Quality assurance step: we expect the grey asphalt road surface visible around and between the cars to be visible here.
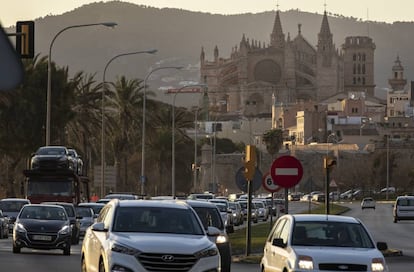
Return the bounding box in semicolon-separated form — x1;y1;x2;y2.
0;202;414;272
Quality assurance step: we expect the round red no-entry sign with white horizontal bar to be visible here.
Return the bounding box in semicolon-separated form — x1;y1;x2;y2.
270;156;303;188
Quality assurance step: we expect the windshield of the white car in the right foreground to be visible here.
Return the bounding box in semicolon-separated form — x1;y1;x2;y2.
291;221;374;248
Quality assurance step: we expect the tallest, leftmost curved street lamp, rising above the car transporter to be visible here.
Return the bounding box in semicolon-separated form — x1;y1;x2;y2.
46;22;117;145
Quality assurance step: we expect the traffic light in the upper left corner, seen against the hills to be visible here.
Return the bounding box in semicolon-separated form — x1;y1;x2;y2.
16;21;34;59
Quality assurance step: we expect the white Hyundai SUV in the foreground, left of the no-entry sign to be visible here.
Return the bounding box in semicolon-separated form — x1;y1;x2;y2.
82;199;221;272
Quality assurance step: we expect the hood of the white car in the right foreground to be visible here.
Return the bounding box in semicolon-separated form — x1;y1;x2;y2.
294;246;383;265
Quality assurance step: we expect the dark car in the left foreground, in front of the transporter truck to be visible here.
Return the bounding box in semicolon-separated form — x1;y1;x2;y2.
13;204;72;255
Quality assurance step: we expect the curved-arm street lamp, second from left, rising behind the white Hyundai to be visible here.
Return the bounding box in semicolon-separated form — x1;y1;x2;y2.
101;49;157;197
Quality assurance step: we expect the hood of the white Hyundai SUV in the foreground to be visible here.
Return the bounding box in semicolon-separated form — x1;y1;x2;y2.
113;232;213;254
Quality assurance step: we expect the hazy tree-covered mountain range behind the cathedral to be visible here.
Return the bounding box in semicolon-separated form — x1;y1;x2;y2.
5;1;414;106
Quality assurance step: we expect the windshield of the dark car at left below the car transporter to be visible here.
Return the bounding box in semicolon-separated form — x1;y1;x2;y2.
19;206;67;221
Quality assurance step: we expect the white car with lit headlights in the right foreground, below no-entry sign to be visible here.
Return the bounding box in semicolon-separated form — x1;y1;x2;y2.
260;214;388;272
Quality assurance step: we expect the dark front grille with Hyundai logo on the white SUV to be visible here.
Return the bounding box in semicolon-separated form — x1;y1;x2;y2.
137;253;197;272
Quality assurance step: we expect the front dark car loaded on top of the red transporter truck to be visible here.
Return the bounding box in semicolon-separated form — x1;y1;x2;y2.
30;146;75;171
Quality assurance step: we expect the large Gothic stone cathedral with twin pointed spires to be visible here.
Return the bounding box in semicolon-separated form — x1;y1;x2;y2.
200;10;375;117
